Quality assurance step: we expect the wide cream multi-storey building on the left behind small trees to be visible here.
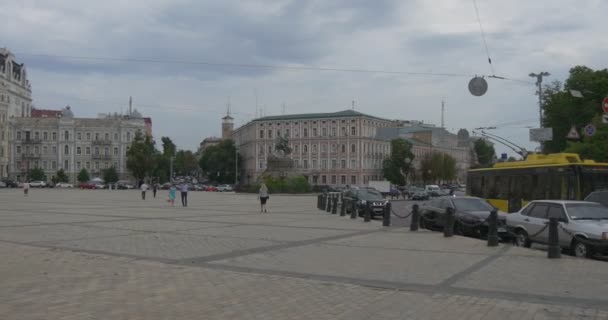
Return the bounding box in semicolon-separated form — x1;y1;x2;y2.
8;106;151;183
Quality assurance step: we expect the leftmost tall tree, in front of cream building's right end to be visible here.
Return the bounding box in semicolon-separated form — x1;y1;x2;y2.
127;131;157;180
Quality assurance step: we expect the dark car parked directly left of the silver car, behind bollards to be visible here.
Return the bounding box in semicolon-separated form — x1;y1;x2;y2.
420;197;510;240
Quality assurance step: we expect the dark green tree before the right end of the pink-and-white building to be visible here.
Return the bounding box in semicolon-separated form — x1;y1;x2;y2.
382;139;414;186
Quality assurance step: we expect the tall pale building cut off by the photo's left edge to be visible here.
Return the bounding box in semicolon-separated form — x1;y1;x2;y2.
0;48;32;178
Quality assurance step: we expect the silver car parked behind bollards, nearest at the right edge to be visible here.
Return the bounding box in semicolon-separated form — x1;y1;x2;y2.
507;200;608;257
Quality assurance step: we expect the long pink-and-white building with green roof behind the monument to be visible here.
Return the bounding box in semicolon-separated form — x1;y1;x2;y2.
232;110;392;186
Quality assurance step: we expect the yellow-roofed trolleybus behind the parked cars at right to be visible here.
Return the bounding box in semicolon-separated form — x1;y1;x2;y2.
467;153;608;212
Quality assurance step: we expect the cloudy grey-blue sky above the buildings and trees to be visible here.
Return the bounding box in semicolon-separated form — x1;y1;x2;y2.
0;0;608;155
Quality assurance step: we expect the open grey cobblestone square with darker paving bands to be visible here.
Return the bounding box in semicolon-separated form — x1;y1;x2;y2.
0;189;608;320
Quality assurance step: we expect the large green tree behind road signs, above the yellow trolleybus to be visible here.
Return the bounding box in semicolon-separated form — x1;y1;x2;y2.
543;66;608;156
